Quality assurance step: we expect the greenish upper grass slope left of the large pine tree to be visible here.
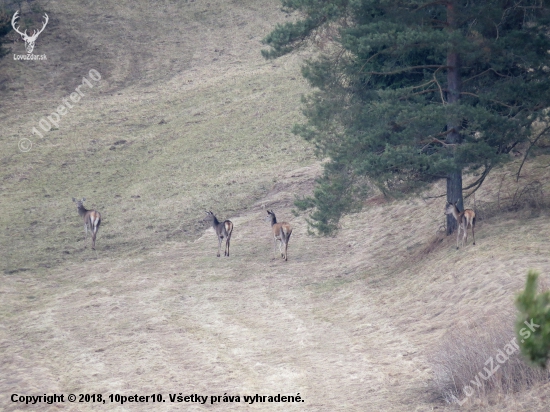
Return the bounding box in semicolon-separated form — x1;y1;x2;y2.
0;1;312;273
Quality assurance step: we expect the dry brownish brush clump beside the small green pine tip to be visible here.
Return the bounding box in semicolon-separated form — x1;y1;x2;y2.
431;308;550;406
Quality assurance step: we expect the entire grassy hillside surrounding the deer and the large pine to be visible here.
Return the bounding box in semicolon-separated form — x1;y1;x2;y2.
0;0;550;411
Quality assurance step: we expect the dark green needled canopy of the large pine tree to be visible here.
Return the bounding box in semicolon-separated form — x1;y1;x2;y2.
262;0;550;234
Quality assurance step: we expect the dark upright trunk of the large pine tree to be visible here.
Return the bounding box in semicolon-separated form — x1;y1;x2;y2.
446;1;464;235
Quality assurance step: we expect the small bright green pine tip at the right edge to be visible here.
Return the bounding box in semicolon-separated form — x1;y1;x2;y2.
516;271;550;368
